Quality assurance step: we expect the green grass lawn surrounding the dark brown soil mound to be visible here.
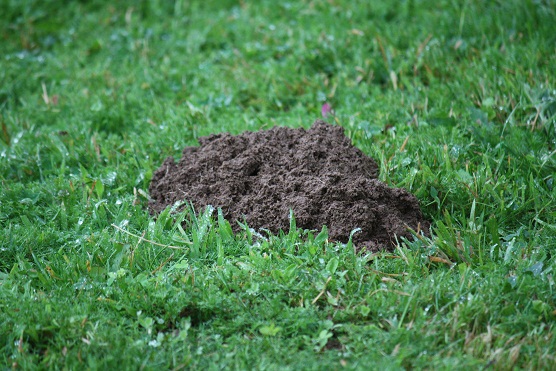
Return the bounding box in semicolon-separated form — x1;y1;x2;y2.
0;0;556;369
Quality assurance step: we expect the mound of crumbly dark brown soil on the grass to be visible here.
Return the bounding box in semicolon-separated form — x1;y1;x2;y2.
149;121;429;250
